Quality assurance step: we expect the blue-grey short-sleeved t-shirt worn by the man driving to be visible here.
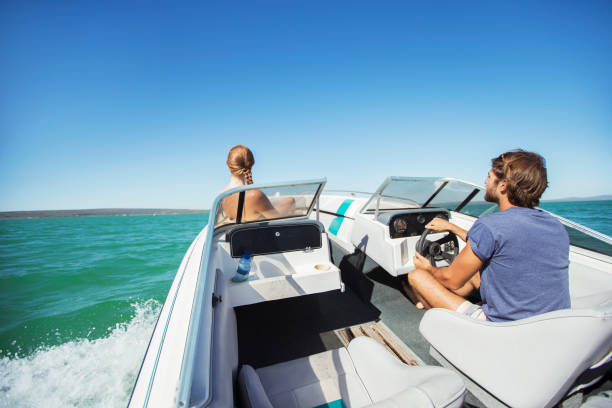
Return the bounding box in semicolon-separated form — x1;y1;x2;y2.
467;207;570;322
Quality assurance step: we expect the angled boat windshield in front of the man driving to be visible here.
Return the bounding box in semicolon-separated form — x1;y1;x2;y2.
362;177;497;217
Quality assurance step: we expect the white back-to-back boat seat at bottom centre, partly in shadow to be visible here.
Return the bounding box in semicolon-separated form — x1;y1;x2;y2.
238;337;465;408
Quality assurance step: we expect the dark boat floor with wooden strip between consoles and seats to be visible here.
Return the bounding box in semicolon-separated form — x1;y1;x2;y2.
235;243;483;407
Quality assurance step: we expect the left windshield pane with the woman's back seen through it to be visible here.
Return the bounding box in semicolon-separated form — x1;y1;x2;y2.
215;179;325;229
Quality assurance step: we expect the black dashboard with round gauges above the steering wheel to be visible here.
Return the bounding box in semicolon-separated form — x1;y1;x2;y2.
378;208;450;238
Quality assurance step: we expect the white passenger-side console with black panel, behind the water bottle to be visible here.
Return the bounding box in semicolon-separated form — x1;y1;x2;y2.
212;220;343;306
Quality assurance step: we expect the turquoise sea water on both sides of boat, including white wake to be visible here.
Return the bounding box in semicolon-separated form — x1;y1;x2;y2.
0;201;612;408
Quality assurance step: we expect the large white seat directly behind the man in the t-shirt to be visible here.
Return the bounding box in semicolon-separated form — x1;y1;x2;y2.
419;304;612;407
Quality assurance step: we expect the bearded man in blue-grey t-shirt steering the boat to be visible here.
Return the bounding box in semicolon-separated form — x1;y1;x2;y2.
408;150;570;322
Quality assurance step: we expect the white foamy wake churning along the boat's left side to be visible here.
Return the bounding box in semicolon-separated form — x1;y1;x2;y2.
0;300;161;408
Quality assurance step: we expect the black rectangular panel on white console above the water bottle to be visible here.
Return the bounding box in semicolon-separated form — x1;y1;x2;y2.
228;223;322;258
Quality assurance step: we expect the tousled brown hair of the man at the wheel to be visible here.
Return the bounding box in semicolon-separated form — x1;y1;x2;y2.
491;149;548;208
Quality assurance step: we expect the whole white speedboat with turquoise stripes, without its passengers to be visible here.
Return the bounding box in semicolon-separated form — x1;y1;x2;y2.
129;177;612;408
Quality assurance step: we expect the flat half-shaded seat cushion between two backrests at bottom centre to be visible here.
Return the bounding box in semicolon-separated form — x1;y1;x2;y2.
257;348;372;408
